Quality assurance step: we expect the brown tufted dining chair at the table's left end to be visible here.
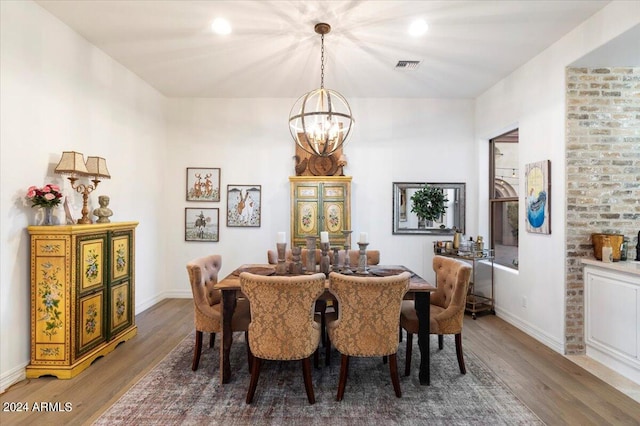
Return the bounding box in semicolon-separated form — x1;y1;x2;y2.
187;254;251;371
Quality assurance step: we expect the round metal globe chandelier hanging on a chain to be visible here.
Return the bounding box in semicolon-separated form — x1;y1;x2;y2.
289;23;355;157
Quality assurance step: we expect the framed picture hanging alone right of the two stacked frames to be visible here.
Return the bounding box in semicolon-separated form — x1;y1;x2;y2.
227;185;262;227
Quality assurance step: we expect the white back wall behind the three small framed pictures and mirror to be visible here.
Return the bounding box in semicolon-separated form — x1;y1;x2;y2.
166;99;477;297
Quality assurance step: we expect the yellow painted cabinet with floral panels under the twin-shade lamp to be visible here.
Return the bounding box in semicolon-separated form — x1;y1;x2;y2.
27;222;137;379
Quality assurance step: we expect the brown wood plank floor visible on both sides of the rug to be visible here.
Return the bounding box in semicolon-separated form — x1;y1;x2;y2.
0;299;640;426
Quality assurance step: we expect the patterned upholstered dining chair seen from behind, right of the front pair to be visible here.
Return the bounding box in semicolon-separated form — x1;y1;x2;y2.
327;272;411;401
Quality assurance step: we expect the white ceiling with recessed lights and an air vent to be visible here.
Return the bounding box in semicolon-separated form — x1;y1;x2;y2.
32;0;609;98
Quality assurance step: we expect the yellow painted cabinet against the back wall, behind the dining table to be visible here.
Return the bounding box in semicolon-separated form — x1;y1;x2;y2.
289;176;351;246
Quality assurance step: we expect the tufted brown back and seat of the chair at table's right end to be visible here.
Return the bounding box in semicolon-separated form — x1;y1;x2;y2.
431;256;471;334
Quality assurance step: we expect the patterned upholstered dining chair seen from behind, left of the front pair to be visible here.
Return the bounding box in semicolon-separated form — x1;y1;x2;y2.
240;272;326;404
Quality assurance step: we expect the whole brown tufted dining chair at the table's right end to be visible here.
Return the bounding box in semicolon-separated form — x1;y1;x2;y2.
400;256;471;376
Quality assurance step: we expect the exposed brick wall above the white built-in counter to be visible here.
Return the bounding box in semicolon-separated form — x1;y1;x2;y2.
565;67;640;354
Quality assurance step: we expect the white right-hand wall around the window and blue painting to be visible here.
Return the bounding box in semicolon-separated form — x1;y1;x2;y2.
475;2;640;352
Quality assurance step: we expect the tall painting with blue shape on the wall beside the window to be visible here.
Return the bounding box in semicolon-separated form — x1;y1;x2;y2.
525;160;551;234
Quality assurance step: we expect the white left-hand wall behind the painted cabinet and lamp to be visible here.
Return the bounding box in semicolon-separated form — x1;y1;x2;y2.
0;1;168;390
